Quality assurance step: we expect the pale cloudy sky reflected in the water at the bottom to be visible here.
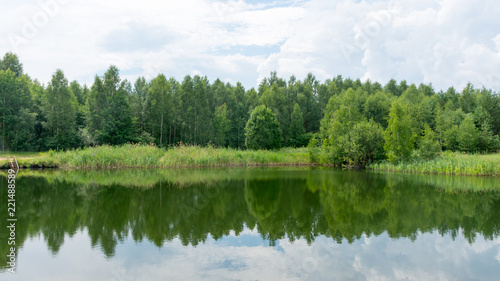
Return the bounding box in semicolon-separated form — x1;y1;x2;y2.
8;229;500;281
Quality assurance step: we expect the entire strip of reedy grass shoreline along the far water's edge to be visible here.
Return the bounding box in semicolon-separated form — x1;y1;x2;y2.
0;144;500;177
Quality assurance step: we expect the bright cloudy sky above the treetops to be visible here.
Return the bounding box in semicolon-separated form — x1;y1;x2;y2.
0;0;500;92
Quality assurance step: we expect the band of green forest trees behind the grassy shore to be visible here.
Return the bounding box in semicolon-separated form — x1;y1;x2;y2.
0;53;500;165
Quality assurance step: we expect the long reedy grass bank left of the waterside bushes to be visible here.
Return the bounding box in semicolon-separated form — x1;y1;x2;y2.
1;144;310;168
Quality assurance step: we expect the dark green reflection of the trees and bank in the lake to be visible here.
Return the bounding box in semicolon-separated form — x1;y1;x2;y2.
0;168;500;266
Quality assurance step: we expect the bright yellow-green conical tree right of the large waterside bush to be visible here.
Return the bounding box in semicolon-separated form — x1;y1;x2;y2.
384;100;417;162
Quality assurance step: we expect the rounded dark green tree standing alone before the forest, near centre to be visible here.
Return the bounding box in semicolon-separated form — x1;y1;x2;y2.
245;105;281;149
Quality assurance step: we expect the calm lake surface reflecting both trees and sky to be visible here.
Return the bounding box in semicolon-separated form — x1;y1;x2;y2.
0;168;500;281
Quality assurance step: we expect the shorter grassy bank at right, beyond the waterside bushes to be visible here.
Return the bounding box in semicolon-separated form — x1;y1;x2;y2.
369;152;500;176
